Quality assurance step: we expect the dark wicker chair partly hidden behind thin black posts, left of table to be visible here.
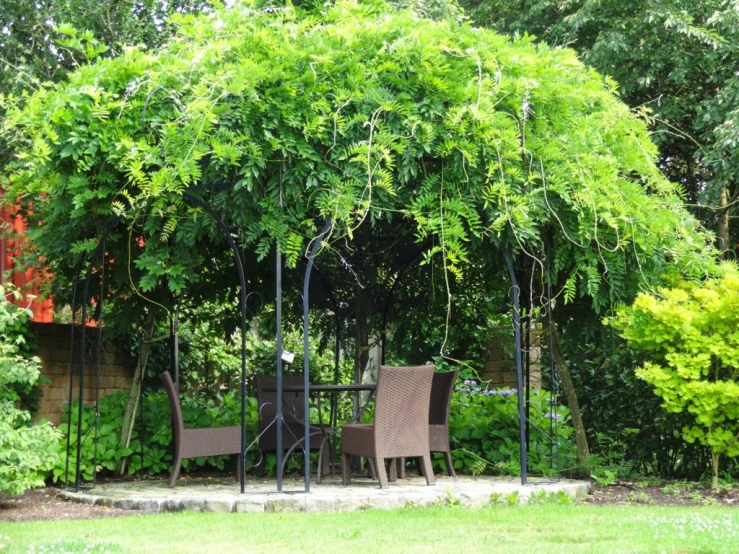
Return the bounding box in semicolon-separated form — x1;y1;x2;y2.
255;375;328;483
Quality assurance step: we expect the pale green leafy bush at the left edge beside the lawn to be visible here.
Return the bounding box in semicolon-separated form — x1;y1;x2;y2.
0;286;58;494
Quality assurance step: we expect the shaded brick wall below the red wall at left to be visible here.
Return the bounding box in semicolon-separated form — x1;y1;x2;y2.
31;323;134;424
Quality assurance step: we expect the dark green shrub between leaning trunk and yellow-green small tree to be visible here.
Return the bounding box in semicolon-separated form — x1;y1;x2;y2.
563;332;710;480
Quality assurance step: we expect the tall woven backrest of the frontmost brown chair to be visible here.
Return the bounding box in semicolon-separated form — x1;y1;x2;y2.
374;365;434;458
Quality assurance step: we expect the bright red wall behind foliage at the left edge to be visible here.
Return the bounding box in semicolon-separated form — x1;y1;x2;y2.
0;199;54;323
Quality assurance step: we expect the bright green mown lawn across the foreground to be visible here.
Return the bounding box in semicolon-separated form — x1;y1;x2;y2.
0;504;739;554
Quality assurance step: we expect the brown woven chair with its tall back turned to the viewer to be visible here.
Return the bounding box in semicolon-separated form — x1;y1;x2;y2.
341;365;435;489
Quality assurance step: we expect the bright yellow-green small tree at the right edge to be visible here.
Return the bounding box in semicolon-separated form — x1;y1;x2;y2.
611;264;739;488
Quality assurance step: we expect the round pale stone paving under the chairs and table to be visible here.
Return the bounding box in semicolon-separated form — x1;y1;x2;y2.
61;470;590;512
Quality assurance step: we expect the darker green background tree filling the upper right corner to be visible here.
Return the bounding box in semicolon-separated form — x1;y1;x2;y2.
460;0;739;254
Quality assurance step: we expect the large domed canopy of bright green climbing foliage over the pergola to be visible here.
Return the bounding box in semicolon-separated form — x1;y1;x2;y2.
4;0;711;308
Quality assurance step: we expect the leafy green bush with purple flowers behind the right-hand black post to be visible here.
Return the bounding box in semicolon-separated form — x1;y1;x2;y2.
448;380;575;475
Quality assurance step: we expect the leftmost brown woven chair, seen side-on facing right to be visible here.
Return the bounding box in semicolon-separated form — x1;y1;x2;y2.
159;371;241;488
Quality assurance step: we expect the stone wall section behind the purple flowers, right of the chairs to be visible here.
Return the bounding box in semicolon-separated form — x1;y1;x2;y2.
481;331;541;389
